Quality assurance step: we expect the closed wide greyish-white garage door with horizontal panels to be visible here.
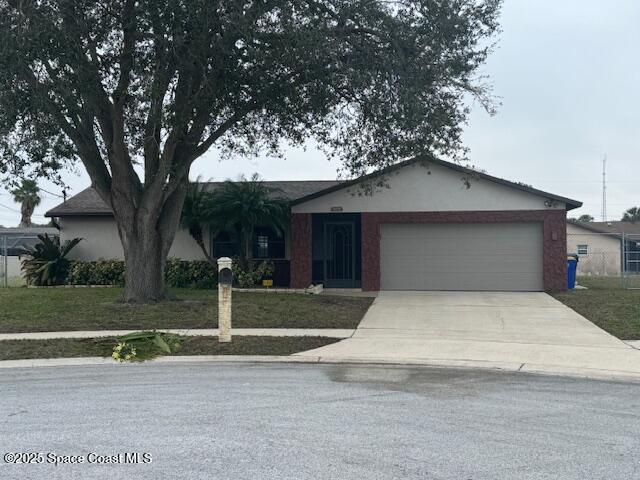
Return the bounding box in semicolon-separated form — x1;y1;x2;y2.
380;223;543;291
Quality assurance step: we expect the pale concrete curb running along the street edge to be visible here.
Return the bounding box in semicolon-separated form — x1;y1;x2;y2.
0;354;640;383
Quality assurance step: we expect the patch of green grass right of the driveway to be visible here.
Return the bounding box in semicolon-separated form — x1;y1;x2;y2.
554;277;640;340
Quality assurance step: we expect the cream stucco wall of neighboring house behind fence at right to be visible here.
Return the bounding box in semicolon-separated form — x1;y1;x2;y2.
567;223;622;276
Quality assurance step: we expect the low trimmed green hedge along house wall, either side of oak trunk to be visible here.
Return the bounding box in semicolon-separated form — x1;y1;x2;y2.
67;258;218;288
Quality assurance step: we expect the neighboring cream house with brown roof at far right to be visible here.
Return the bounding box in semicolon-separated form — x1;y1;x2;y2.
567;221;640;276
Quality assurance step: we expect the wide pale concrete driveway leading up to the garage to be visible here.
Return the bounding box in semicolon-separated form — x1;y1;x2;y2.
298;292;640;379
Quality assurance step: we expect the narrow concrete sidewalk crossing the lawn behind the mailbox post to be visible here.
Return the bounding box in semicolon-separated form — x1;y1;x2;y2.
0;328;354;341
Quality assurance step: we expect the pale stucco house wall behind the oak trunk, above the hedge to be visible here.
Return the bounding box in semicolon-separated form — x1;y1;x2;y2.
58;217;210;260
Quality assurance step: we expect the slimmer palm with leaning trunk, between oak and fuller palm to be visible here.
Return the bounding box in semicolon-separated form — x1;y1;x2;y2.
180;177;216;266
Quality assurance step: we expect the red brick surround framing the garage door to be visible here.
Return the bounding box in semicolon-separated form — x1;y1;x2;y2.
362;210;567;292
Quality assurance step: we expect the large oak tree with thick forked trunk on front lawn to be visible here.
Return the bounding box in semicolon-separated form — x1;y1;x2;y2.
0;0;500;302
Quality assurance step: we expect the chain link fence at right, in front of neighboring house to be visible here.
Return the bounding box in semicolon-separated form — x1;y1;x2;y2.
567;232;640;289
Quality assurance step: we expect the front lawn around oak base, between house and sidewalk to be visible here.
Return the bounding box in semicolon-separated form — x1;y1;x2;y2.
0;288;373;333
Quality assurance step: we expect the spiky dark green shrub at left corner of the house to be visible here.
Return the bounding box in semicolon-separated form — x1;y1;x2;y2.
22;233;82;286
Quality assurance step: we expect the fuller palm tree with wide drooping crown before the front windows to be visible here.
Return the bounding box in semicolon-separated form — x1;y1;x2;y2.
209;173;290;270
